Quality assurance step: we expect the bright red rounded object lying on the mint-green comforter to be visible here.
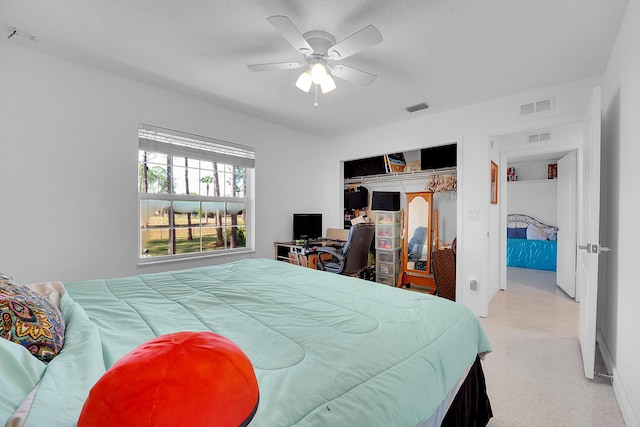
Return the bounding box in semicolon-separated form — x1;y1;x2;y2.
78;332;259;427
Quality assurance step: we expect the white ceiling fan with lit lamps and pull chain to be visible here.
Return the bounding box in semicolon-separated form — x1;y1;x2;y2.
247;15;382;107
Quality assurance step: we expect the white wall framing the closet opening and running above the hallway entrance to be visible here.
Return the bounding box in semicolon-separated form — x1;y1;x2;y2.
327;78;600;316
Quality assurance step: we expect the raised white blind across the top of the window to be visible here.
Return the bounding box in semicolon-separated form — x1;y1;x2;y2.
138;124;255;168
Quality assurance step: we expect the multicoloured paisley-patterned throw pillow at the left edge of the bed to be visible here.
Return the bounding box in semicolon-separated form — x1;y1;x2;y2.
0;273;65;362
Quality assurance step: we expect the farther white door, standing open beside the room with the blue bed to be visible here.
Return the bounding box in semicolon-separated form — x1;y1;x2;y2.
556;151;578;298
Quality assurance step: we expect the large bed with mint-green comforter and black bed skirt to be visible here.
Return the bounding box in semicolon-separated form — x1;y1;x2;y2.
0;259;491;427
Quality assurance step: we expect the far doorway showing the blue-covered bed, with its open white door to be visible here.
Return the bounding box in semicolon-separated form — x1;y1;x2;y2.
501;150;577;298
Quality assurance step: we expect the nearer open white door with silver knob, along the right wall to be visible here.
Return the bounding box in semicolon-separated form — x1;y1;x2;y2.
576;87;601;379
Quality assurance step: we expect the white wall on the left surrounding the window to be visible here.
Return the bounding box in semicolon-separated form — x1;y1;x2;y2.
0;41;324;282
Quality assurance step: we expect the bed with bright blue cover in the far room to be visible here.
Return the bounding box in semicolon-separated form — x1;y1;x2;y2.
507;214;558;271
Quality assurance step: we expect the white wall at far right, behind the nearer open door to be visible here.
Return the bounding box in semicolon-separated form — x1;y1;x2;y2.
598;0;640;426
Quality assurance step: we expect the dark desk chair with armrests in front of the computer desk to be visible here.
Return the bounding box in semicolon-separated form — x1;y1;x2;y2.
318;224;375;276
